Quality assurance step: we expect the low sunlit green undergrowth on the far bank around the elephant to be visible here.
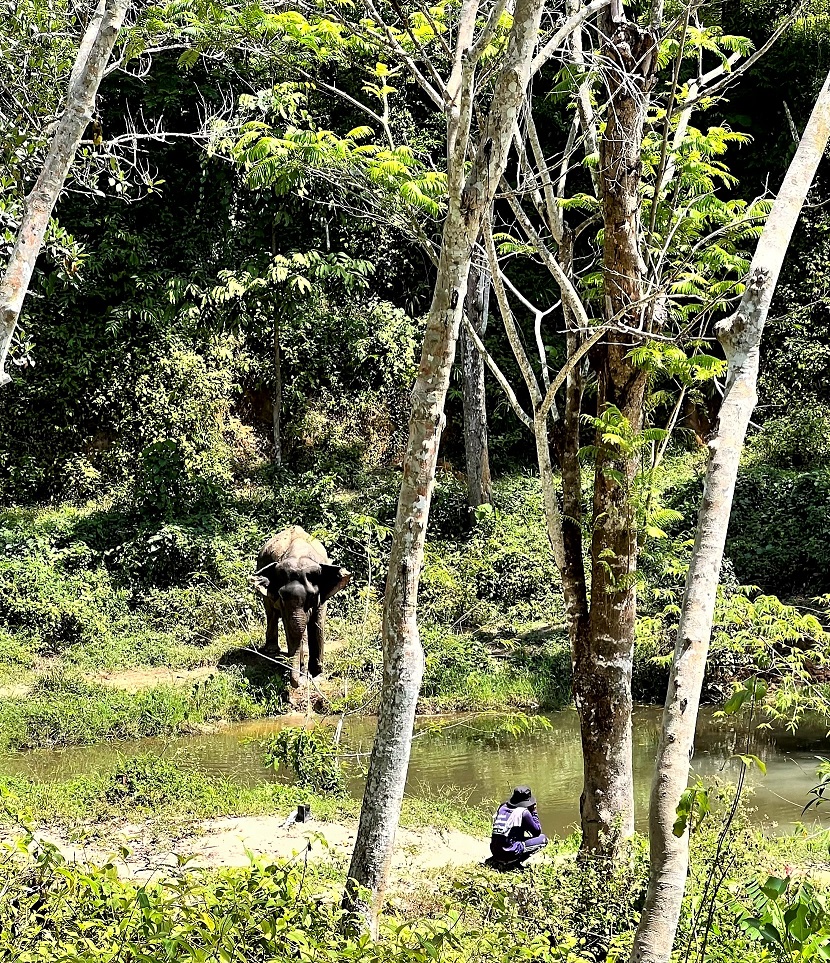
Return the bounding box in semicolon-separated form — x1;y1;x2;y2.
0;466;830;749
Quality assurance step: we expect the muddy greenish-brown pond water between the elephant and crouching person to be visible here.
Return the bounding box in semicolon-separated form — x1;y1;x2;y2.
0;707;830;834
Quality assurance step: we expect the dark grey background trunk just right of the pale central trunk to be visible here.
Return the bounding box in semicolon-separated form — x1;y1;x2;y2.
460;266;492;508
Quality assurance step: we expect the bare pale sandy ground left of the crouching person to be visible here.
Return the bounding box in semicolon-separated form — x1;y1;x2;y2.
32;816;489;878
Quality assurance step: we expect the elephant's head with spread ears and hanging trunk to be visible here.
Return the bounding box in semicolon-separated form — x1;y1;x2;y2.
251;558;352;686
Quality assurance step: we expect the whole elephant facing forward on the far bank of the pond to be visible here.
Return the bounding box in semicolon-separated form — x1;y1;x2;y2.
251;525;352;688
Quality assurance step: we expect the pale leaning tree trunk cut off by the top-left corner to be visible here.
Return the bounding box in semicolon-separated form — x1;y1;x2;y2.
0;0;128;387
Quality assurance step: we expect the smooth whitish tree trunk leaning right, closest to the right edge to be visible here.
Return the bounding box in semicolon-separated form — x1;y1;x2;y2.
632;69;830;963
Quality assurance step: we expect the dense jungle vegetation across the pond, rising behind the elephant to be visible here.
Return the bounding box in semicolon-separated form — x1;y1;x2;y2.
0;4;830;747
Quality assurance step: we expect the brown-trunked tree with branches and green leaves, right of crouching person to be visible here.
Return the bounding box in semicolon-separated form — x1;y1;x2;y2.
470;0;796;853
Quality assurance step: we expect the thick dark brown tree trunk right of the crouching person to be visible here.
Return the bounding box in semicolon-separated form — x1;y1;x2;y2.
573;6;657;854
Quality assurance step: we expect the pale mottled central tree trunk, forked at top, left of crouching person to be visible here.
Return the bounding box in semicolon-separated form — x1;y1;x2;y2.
343;0;545;933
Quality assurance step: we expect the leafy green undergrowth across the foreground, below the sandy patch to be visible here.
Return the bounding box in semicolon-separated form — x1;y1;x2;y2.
0;804;828;963
